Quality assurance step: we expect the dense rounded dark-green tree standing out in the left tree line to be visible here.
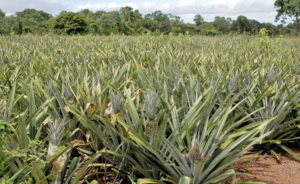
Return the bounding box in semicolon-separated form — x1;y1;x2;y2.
52;12;87;35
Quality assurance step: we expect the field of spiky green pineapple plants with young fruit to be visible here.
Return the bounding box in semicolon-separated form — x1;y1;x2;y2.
0;32;300;184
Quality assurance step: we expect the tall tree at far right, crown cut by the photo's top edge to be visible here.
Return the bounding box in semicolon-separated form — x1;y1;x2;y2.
274;0;300;34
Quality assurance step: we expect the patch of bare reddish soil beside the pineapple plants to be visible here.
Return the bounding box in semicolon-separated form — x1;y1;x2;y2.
235;151;300;184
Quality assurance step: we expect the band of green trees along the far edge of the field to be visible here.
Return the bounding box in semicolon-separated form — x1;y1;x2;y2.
0;0;300;35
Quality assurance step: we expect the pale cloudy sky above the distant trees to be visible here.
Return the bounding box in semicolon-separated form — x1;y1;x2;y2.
0;0;282;23
